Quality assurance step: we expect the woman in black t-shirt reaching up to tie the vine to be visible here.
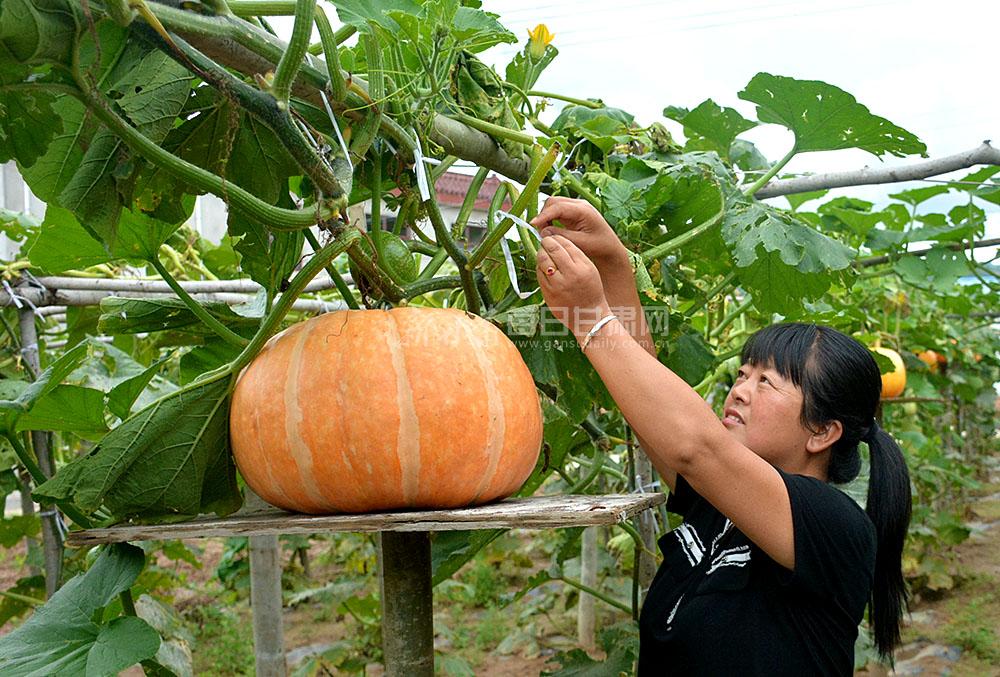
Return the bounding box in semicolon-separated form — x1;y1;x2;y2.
532;197;910;675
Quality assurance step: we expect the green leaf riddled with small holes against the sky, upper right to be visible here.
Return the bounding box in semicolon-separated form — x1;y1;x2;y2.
739;73;927;157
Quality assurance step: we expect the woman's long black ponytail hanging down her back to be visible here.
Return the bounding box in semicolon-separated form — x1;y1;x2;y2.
862;423;911;662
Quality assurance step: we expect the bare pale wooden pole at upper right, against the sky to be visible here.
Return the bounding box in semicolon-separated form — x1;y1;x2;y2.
756;141;1000;199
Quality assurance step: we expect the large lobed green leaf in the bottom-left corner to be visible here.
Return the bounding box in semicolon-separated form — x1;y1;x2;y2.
0;543;160;677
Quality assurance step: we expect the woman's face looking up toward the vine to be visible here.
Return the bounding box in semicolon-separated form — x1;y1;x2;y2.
722;364;812;472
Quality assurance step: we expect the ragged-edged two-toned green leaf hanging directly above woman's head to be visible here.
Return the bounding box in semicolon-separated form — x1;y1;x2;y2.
722;194;854;316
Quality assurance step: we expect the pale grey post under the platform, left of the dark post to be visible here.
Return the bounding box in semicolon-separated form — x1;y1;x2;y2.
250;534;287;677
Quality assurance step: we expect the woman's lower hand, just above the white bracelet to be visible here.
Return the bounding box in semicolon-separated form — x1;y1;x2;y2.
535;234;611;340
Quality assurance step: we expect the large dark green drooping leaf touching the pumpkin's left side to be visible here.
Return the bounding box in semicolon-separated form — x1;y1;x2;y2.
34;374;241;519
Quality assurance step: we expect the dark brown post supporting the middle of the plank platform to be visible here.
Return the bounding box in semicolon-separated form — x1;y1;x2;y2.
378;531;434;677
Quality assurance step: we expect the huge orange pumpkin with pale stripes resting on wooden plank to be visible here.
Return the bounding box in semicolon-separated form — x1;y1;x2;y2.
229;307;542;514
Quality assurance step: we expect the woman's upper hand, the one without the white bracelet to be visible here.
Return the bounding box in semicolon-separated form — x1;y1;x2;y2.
531;196;631;276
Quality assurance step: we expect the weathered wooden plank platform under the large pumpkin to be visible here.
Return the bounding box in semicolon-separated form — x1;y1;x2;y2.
66;494;666;547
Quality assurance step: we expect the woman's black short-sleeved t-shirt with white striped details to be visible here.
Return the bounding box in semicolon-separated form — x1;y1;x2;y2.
639;470;875;677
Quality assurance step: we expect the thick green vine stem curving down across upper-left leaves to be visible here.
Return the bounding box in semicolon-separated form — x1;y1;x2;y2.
79;79;335;230
